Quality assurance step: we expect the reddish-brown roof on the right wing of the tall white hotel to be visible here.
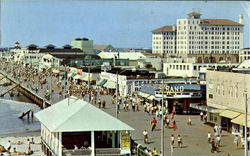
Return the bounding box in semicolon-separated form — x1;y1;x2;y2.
200;19;244;26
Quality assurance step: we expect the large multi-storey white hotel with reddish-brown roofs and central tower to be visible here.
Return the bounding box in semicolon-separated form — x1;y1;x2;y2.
152;12;244;63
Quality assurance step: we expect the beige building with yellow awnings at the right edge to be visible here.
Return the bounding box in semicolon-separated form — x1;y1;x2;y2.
206;71;250;135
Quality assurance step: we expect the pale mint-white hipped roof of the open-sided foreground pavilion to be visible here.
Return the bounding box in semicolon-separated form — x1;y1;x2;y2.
35;96;134;132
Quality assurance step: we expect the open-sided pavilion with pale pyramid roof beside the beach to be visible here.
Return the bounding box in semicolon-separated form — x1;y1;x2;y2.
35;96;134;156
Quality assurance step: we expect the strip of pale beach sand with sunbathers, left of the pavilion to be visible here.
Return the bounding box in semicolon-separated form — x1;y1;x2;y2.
0;134;45;156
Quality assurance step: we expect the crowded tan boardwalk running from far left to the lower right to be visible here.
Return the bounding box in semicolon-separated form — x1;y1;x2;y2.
0;62;244;156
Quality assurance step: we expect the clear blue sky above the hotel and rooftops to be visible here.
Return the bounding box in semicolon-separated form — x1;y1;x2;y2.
1;0;250;48
